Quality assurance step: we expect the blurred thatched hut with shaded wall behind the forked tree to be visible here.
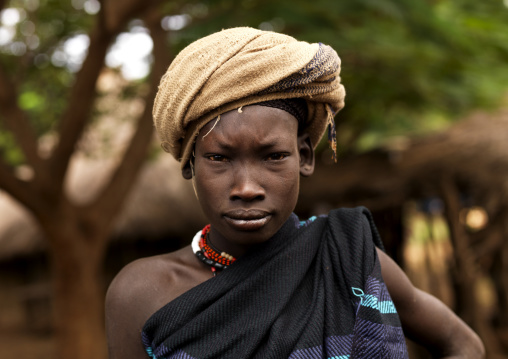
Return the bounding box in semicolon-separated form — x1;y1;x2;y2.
0;155;205;331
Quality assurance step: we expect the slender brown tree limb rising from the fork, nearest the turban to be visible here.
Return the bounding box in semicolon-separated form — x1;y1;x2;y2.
91;11;171;228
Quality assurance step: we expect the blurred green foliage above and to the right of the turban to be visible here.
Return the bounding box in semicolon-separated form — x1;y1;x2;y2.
181;0;508;148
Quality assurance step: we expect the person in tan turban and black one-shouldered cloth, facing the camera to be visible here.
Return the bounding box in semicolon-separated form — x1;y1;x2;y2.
106;28;484;359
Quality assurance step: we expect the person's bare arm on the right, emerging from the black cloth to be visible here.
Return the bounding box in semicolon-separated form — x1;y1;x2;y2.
377;249;485;359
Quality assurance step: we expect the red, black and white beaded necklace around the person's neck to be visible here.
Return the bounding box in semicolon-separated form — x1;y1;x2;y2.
192;224;236;276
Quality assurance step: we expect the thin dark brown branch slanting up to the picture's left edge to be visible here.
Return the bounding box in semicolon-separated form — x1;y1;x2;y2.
0;63;41;170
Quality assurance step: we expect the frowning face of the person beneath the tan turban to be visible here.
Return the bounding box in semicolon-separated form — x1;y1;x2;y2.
184;106;314;255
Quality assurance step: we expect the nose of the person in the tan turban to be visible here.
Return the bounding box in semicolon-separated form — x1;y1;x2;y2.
229;166;266;202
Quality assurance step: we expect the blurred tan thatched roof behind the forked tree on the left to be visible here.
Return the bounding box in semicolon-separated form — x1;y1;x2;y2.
0;154;205;261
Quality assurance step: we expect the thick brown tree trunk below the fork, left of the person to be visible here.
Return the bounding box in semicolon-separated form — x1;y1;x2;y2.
43;208;109;359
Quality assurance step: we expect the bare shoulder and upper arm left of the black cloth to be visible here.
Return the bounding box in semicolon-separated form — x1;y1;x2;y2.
105;247;210;359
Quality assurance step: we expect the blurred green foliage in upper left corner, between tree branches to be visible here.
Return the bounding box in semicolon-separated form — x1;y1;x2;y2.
0;0;93;165
